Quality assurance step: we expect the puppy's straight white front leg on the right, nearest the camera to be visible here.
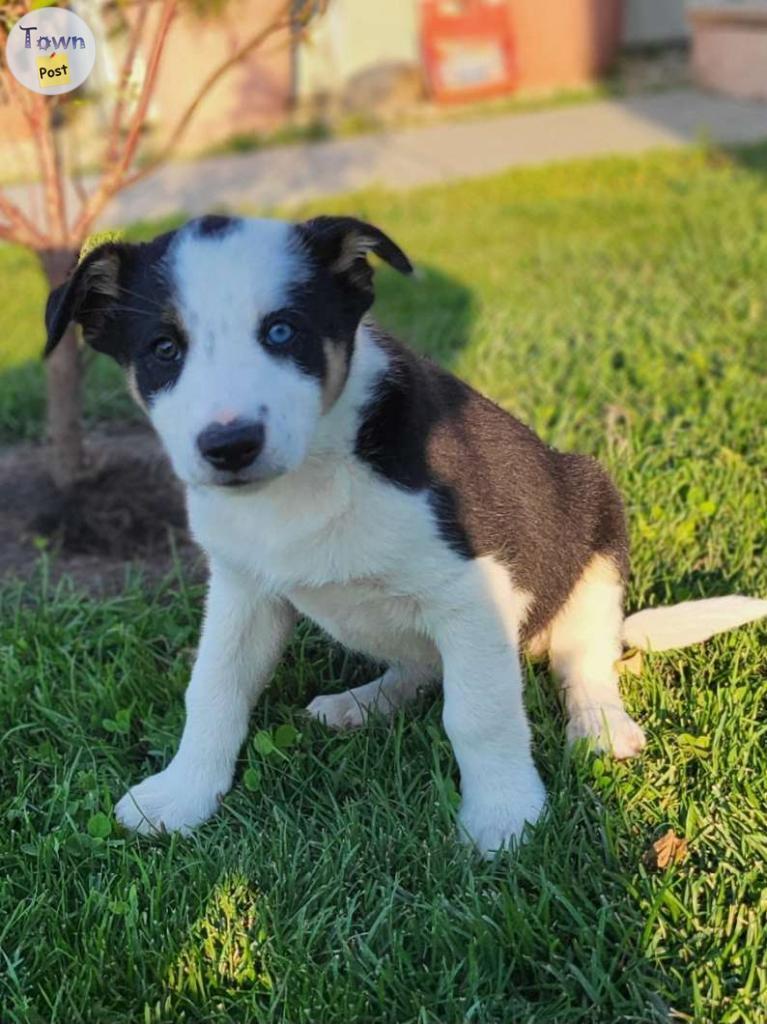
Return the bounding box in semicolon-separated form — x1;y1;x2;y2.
430;558;546;856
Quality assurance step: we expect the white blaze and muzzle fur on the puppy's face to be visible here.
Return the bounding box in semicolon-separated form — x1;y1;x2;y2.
150;220;323;485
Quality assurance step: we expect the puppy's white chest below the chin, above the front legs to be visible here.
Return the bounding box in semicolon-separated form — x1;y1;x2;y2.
188;460;445;589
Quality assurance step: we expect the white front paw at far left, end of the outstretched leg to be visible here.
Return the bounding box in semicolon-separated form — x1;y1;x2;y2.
115;766;228;836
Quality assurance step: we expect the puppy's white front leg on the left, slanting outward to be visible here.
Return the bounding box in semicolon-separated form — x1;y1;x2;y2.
115;563;296;833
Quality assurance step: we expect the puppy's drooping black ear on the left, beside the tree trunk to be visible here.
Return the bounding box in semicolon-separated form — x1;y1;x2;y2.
43;242;127;355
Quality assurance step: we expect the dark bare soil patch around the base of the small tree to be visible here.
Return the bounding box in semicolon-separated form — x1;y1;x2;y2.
0;424;204;594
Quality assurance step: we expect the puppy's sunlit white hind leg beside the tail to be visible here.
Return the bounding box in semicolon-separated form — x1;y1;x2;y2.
549;555;645;759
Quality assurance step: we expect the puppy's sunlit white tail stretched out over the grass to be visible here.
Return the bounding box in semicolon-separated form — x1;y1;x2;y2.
623;594;767;651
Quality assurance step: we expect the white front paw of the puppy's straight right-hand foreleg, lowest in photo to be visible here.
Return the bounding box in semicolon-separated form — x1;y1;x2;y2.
458;767;546;859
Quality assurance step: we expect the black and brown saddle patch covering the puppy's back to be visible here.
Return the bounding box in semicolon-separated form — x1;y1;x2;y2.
356;337;628;641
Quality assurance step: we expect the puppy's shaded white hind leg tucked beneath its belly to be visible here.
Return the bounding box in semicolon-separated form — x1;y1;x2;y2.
306;665;436;729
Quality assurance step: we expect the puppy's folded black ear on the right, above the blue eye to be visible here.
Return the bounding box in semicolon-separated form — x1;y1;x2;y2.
300;217;413;287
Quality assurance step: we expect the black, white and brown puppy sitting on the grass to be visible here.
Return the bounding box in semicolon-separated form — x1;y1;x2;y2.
46;217;767;854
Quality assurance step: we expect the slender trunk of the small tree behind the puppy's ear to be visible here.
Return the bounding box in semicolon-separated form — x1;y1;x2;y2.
40;249;85;490
